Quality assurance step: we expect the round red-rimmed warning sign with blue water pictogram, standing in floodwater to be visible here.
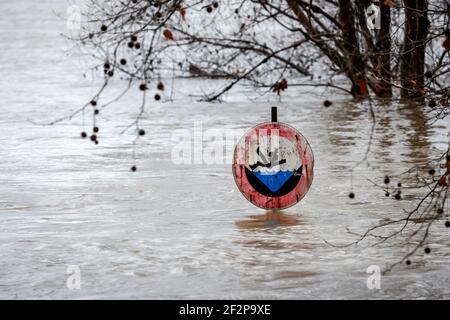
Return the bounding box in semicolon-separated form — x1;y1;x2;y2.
233;122;314;209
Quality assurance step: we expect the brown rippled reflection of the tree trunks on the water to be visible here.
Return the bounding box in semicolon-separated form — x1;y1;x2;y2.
327;99;433;170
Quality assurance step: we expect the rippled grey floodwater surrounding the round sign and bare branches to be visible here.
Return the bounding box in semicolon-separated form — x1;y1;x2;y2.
0;0;450;299
